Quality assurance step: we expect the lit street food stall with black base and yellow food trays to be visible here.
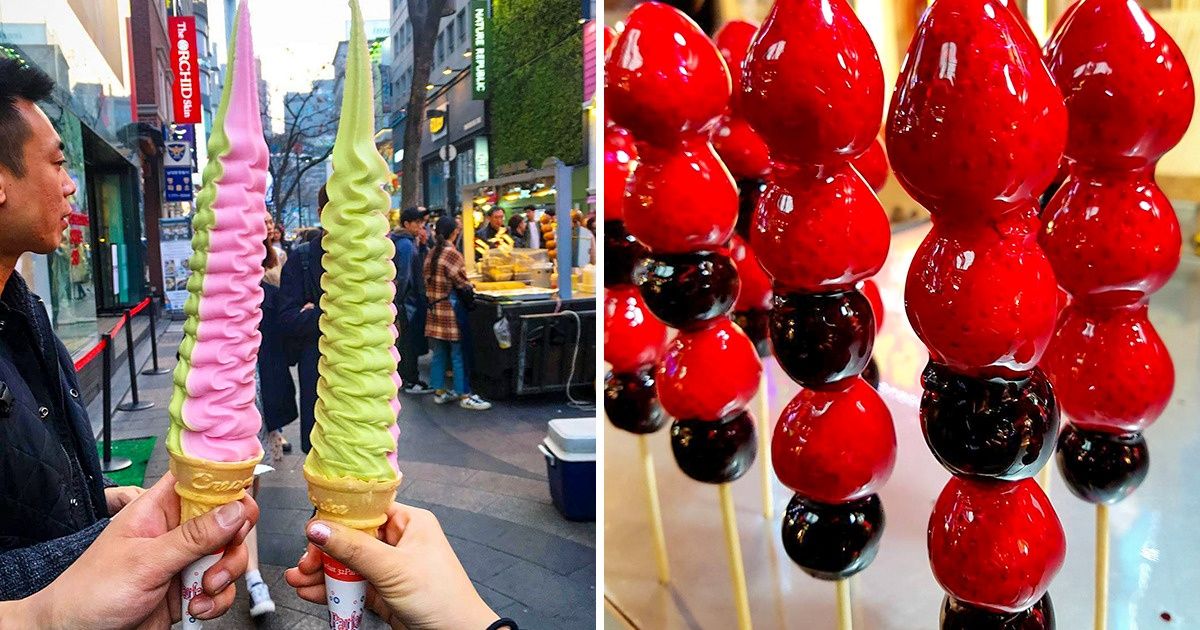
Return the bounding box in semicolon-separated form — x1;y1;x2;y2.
461;164;596;400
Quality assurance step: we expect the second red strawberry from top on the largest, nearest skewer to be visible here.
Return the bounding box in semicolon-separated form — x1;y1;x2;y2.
905;213;1058;376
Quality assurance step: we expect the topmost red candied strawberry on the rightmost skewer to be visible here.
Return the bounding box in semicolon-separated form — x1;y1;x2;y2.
1046;0;1195;170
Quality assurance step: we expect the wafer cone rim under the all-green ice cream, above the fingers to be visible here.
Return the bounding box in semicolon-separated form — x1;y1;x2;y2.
304;469;400;535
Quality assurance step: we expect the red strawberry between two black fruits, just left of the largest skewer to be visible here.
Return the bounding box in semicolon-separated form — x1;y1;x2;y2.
770;378;896;504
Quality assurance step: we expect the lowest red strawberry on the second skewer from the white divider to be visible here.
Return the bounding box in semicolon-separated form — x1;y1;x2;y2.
656;318;762;420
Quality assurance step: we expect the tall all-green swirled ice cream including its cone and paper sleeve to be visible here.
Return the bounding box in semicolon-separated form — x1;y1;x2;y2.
304;0;401;625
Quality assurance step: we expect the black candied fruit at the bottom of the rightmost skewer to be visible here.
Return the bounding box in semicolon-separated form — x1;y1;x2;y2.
1058;425;1150;504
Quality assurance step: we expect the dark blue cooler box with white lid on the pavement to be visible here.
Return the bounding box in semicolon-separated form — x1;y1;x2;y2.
538;418;596;521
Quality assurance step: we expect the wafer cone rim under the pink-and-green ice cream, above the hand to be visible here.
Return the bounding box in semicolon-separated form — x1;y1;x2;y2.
170;452;263;522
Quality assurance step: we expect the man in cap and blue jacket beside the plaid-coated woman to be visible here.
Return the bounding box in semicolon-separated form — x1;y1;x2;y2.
392;208;433;395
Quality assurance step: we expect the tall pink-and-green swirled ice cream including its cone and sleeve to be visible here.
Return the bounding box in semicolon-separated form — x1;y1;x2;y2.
167;0;268;628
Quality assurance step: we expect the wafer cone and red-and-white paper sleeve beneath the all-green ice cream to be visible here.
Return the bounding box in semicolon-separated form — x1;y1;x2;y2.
304;469;401;630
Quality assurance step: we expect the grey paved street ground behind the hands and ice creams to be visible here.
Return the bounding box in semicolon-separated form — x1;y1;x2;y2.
104;323;596;630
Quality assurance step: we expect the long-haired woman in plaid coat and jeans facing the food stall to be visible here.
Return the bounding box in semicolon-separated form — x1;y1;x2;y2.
425;216;492;410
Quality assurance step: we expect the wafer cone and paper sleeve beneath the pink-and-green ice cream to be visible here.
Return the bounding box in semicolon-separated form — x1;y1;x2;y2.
170;452;263;630
